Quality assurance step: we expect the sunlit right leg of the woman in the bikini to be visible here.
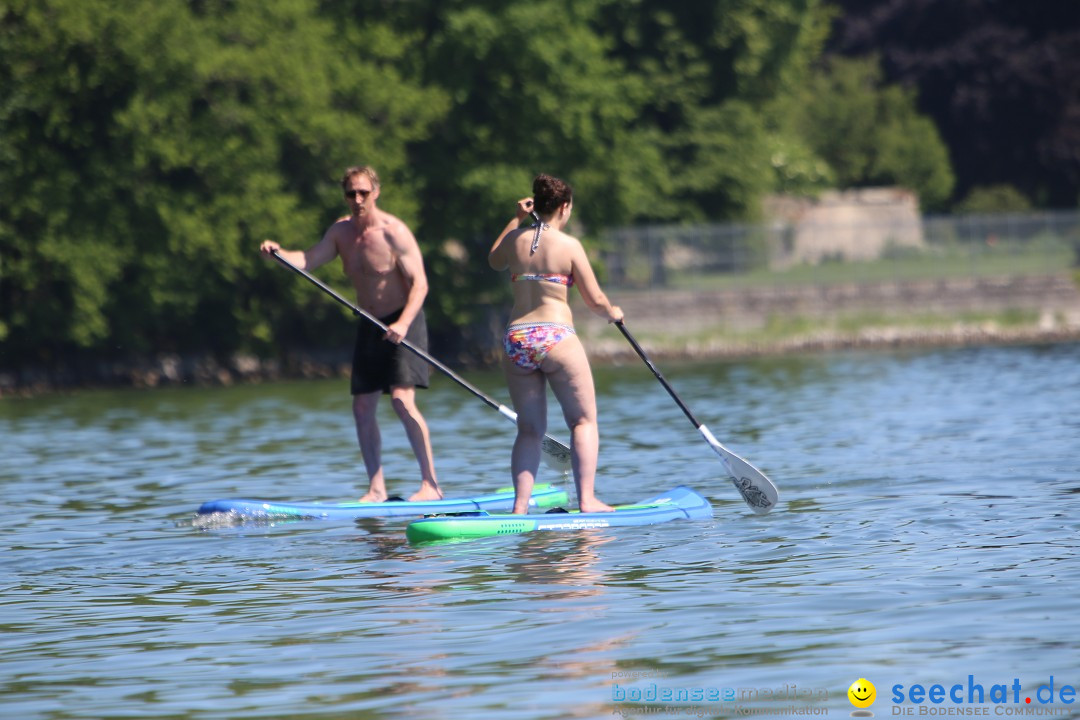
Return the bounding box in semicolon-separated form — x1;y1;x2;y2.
540;335;612;513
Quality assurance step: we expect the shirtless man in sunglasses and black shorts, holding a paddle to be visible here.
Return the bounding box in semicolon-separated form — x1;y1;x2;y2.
259;166;443;502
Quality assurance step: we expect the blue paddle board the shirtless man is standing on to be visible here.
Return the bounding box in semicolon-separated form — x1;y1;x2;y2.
199;485;567;520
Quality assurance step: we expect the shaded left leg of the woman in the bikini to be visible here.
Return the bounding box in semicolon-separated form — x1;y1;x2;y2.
502;357;548;513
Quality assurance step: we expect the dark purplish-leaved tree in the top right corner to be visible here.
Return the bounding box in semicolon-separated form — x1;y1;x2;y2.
828;0;1080;207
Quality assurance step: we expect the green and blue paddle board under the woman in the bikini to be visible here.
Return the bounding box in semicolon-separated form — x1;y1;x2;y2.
405;485;713;543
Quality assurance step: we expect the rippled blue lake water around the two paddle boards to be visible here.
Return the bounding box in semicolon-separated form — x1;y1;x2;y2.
0;344;1080;720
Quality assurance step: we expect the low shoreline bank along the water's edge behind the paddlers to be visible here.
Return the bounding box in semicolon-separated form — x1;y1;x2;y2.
8;271;1080;399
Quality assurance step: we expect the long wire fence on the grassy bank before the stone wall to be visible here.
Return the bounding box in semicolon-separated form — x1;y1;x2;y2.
602;210;1080;290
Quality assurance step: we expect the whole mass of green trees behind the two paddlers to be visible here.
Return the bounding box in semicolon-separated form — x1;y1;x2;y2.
0;0;924;375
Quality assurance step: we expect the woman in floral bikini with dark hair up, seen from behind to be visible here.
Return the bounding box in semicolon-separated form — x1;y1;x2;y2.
488;175;622;513
